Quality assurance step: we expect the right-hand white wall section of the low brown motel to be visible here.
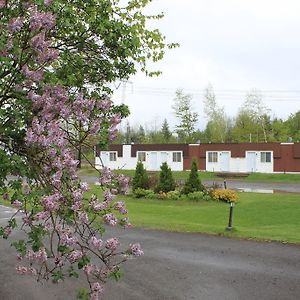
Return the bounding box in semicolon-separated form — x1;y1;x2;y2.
206;151;274;173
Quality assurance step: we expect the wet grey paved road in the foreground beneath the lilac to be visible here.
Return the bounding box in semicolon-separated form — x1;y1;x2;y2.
0;207;300;300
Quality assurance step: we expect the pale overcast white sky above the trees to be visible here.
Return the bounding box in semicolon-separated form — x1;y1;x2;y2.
114;0;300;129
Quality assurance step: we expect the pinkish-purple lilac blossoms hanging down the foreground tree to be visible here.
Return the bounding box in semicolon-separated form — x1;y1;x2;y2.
0;0;143;300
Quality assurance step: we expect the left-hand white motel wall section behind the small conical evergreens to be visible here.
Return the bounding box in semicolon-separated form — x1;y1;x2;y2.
95;145;183;171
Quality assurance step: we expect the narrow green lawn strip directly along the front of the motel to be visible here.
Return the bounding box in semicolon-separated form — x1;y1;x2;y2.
78;165;300;183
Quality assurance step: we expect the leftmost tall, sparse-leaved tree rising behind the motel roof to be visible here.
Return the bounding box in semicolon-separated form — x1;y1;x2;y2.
172;90;198;143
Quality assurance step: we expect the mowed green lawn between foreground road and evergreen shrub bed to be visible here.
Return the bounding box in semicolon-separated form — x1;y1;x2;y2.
119;193;300;243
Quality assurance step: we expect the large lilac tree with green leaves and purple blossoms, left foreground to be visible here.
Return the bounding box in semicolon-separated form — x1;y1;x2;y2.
0;0;175;299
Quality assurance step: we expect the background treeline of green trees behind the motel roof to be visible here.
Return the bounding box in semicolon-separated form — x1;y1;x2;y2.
115;86;300;144
